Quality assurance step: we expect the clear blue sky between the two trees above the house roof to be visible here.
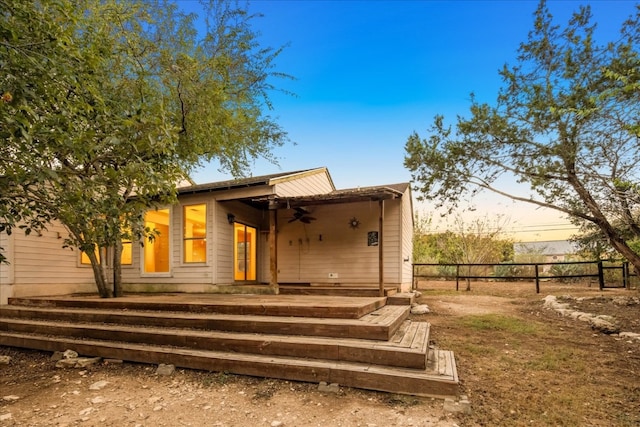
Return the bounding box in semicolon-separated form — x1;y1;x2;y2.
182;0;635;241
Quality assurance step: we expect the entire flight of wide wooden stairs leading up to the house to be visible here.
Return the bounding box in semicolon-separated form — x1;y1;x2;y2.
0;294;458;398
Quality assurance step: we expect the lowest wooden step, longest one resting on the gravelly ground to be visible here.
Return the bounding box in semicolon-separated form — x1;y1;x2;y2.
0;332;458;398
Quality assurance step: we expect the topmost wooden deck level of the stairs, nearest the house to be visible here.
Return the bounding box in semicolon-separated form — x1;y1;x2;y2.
9;294;386;319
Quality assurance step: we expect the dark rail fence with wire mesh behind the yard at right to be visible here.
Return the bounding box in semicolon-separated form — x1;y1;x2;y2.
412;260;638;293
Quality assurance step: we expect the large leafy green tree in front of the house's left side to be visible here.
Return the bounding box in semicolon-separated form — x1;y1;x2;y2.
0;0;286;296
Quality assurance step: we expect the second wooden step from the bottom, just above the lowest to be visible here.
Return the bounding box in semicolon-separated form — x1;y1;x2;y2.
0;318;429;369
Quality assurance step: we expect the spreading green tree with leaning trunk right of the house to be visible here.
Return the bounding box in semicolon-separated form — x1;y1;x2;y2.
405;0;640;269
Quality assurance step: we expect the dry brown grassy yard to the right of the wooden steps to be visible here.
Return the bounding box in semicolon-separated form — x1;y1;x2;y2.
420;282;640;426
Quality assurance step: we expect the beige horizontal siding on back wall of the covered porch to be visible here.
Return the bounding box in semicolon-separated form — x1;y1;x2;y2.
278;201;401;284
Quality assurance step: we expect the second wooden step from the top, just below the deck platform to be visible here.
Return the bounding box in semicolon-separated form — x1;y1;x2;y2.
0;305;409;341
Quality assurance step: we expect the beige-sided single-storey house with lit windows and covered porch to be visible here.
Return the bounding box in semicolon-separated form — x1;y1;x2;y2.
0;167;413;304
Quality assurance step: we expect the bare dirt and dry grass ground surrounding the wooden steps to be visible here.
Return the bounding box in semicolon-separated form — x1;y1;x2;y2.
0;282;640;427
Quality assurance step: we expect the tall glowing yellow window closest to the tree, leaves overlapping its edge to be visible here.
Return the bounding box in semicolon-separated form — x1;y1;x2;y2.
144;209;169;273
